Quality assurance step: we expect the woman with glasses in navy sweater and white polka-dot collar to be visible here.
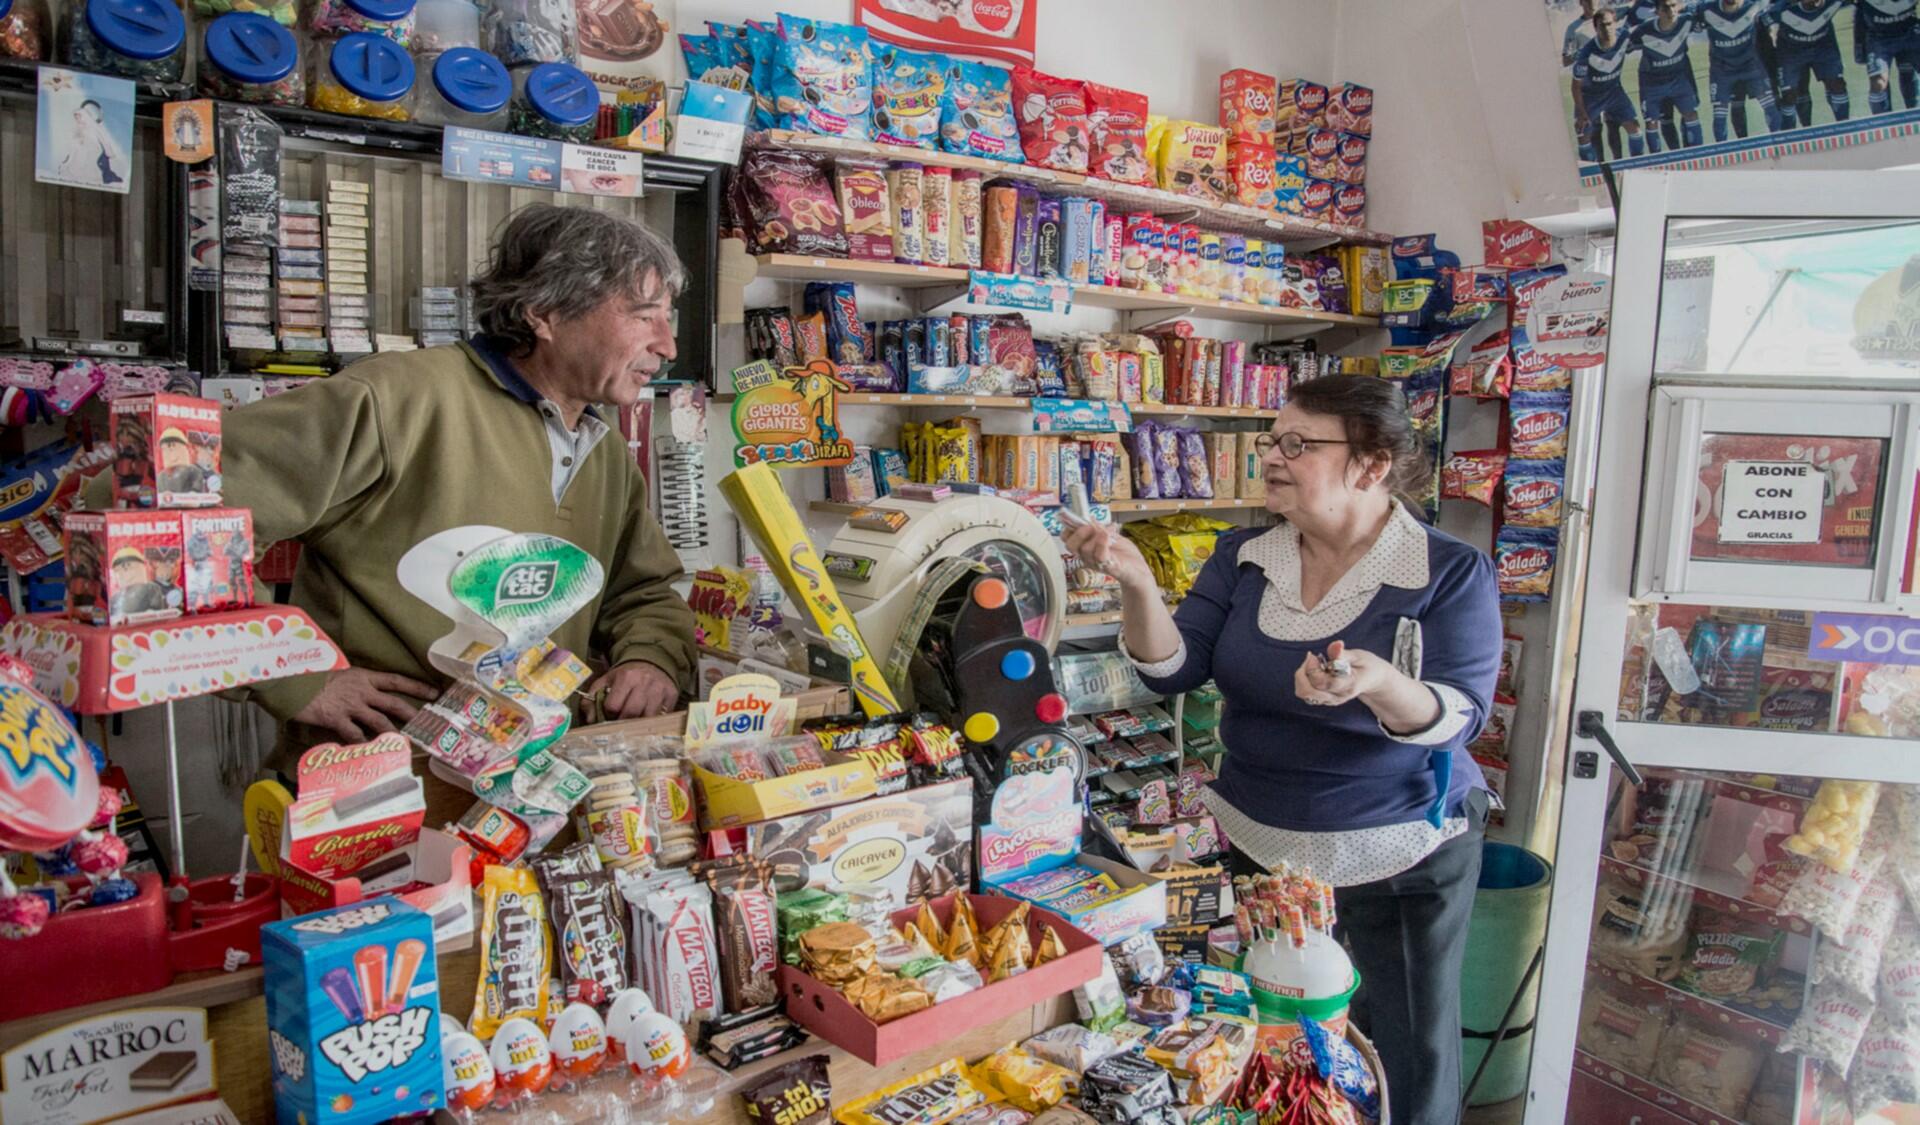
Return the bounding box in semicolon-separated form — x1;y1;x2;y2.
1066;376;1501;1123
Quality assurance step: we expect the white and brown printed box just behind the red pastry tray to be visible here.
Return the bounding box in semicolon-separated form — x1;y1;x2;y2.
745;770;973;908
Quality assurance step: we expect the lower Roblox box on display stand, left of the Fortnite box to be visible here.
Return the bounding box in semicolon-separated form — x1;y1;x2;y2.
63;511;186;626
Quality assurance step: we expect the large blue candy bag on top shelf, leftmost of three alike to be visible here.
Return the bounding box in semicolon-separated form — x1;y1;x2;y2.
774;13;874;140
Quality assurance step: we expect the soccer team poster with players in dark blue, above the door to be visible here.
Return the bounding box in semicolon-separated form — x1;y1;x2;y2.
1546;0;1920;180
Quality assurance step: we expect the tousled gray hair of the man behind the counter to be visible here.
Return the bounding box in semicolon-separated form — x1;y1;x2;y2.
470;203;685;355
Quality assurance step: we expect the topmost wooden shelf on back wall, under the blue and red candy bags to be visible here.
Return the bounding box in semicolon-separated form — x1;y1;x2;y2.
760;129;1394;246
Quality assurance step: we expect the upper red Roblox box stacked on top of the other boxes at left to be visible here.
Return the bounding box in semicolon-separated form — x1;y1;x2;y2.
113;394;221;509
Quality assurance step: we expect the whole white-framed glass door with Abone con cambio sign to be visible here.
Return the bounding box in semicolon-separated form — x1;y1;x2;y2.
1521;173;1920;1125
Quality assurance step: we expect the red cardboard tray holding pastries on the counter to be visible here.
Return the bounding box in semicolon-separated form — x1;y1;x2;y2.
764;895;1100;1065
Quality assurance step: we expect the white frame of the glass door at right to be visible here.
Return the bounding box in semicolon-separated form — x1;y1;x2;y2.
1536;171;1920;1125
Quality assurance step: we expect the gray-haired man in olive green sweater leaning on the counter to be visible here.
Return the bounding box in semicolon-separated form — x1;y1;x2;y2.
140;203;695;751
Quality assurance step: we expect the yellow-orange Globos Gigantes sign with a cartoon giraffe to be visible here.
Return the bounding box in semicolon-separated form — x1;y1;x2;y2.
733;359;852;468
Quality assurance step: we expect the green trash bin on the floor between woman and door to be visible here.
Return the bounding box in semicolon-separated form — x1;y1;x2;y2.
1459;841;1553;1106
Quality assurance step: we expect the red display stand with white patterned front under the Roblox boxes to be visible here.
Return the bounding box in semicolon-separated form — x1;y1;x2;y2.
0;605;348;714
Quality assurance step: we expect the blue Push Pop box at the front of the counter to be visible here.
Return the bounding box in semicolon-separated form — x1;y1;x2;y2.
259;898;442;1125
